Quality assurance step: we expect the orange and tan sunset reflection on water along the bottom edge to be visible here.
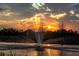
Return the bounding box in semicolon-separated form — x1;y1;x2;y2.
0;48;62;56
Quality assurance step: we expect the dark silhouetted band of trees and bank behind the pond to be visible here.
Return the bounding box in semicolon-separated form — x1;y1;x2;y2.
0;28;79;44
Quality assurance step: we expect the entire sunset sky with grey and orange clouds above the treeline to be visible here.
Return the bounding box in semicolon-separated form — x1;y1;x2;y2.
0;3;79;31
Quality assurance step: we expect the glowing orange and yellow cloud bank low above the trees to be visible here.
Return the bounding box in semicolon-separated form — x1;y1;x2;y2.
2;13;66;31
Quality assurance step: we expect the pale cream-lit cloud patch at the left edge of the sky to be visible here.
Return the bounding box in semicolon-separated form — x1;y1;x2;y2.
0;10;20;20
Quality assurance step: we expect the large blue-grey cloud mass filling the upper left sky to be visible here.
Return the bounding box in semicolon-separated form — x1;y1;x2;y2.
0;3;35;20
